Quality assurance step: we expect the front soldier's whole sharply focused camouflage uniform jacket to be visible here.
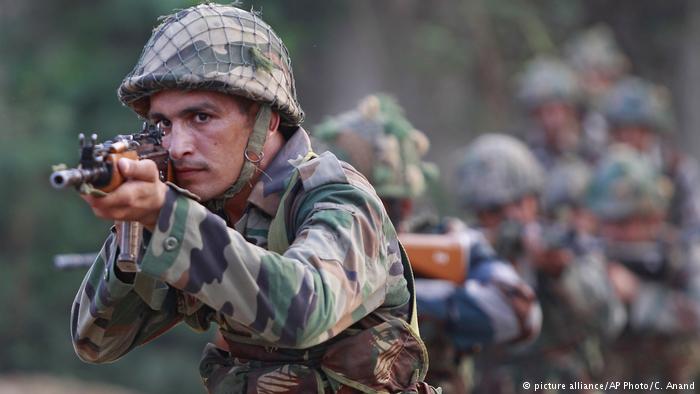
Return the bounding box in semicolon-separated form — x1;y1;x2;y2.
71;129;427;392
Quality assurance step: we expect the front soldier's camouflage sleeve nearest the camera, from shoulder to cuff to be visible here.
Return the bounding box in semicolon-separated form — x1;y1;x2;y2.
142;184;400;348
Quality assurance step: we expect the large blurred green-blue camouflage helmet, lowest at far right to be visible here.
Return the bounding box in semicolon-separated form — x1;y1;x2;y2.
586;145;673;221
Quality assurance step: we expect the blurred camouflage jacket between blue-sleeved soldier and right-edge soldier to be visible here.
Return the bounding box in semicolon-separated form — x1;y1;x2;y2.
513;245;627;383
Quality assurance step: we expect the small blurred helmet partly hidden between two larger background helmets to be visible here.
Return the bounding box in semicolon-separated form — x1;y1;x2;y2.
541;156;591;216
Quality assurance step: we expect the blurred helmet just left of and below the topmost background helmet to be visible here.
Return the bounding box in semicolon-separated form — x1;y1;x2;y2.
518;56;581;109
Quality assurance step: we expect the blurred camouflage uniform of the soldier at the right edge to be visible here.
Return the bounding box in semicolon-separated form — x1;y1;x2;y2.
606;232;700;386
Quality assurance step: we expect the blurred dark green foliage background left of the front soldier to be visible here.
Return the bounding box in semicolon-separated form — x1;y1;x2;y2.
0;0;215;393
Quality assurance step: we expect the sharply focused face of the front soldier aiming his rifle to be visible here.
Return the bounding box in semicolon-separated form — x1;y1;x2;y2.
148;90;257;201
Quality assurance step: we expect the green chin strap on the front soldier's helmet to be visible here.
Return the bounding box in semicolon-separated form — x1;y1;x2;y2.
204;104;272;212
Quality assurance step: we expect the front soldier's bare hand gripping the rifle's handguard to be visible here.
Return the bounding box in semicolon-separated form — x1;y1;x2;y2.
82;158;168;231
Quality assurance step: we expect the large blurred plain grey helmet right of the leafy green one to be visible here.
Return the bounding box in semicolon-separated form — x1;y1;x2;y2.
455;134;543;210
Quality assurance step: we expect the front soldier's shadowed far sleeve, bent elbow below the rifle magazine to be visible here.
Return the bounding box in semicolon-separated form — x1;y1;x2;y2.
71;229;180;363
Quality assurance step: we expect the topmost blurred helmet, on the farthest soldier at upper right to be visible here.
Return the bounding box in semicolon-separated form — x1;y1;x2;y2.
564;25;628;77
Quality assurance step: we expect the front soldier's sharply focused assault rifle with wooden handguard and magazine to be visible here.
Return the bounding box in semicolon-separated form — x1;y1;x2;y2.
49;122;173;272
